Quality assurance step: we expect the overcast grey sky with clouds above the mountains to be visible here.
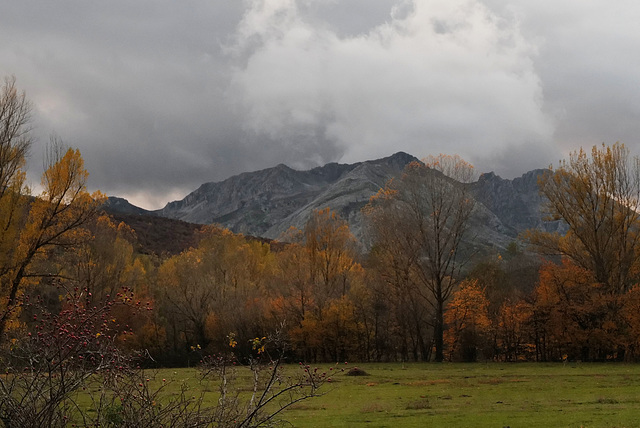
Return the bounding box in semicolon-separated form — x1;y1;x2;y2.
0;0;640;209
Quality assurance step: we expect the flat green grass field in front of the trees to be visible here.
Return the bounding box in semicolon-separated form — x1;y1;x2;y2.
130;363;640;427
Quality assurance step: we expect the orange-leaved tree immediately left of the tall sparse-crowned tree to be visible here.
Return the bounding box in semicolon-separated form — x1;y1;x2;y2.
278;208;364;360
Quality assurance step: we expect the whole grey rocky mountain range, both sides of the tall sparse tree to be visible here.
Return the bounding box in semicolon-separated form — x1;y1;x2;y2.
109;152;566;250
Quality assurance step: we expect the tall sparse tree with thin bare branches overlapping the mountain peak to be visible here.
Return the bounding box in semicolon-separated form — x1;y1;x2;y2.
365;154;474;361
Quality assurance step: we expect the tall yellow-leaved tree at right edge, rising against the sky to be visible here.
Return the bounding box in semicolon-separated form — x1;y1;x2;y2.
526;143;640;359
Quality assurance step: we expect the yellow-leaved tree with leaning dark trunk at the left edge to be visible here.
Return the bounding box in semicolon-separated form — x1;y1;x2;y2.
0;77;109;340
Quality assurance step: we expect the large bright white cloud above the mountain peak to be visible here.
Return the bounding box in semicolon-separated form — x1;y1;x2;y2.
233;0;553;176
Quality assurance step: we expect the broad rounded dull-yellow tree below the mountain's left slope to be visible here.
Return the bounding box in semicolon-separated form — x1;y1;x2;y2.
155;226;271;356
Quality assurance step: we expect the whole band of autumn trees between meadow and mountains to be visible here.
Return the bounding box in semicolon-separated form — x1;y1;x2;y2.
0;78;640;374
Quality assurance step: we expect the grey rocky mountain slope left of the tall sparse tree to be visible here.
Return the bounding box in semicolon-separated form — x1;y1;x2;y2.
155;152;417;239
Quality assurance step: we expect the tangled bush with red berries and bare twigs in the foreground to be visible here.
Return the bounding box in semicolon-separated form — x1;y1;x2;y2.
0;289;326;428
